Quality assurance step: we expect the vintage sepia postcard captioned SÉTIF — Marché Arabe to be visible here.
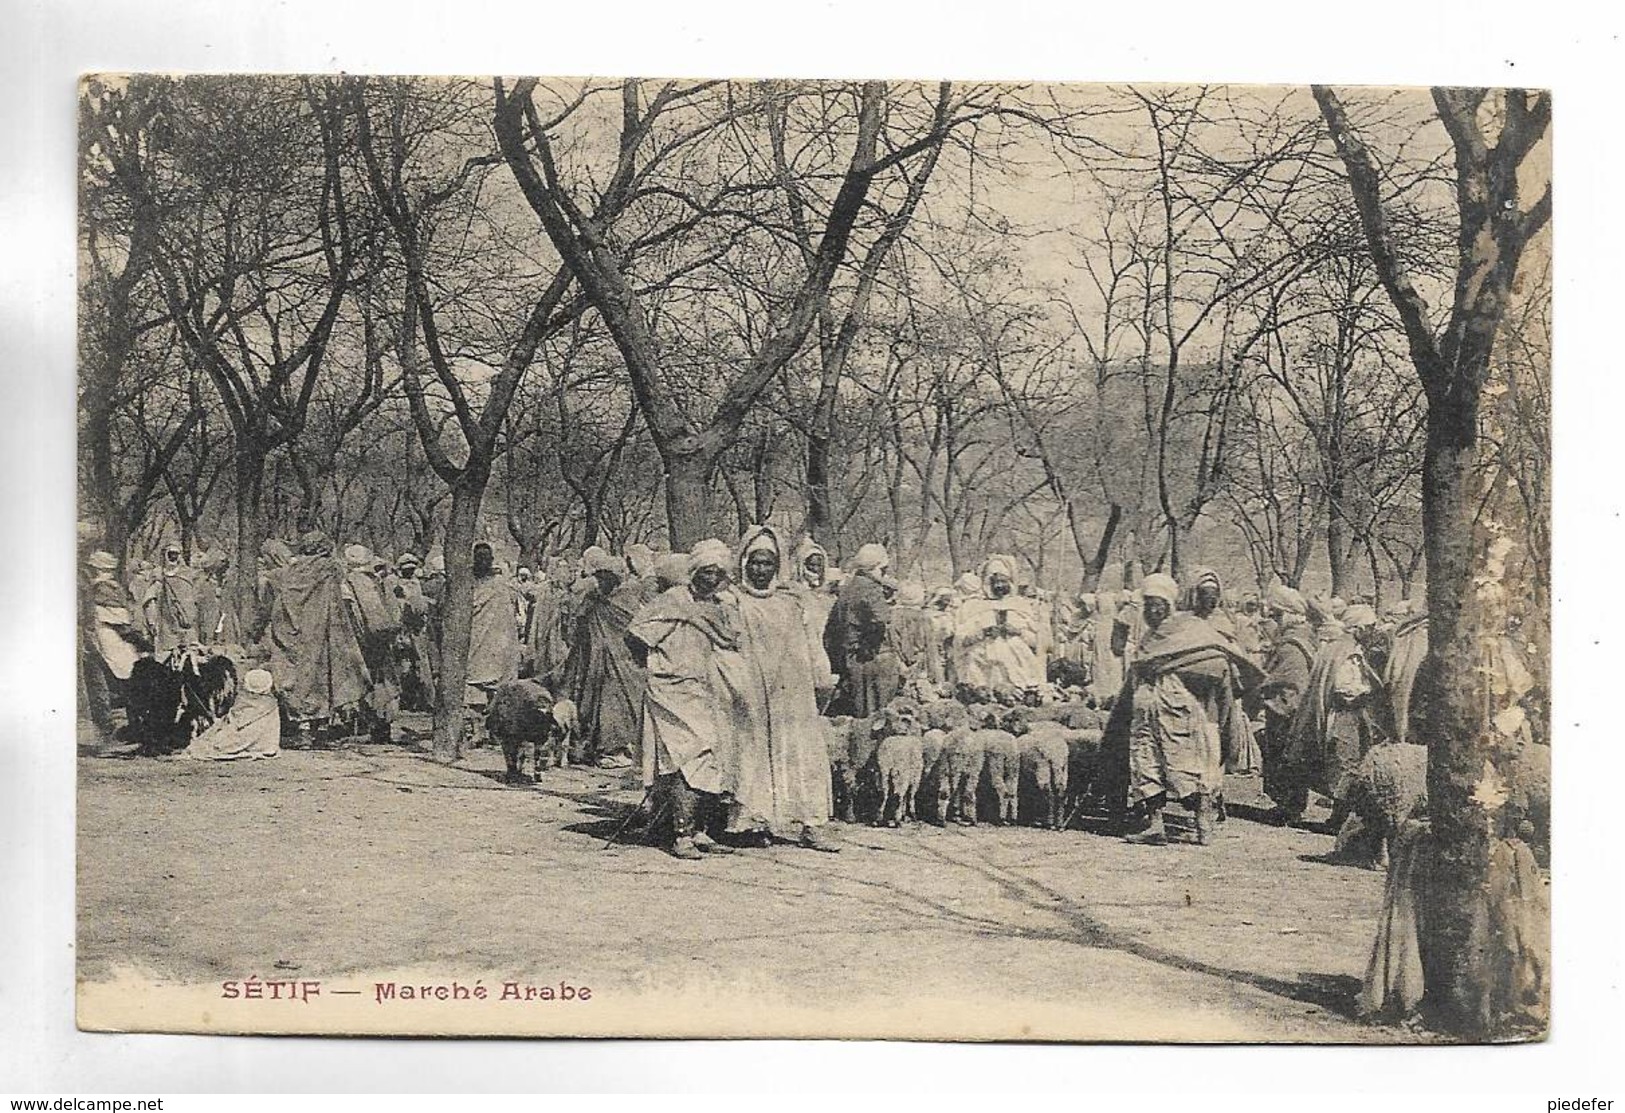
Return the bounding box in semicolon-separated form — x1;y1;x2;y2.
76;73;1552;1043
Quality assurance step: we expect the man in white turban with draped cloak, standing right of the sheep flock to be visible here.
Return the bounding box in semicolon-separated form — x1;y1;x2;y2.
1128;572;1258;845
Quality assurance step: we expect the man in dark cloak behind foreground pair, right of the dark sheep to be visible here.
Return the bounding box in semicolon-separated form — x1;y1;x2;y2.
562;546;644;769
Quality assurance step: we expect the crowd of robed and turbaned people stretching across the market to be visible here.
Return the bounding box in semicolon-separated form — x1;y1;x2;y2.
83;526;1427;858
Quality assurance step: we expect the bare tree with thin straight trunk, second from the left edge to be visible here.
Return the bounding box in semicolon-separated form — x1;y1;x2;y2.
158;78;359;617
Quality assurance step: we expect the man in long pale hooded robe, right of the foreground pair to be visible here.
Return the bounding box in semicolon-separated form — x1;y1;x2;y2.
718;526;839;851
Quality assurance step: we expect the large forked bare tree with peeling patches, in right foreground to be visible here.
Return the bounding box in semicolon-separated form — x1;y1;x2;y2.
1315;86;1552;1037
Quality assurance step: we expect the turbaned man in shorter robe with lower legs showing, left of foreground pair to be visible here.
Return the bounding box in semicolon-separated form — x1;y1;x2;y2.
626;539;739;858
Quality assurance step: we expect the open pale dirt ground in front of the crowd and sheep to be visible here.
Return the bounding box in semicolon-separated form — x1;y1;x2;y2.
78;711;1415;1042
